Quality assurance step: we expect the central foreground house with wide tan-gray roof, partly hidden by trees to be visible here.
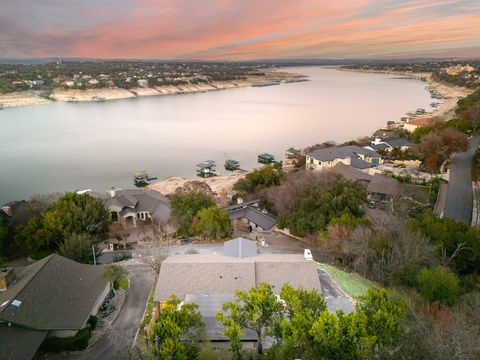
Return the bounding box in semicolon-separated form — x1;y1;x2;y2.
154;238;321;346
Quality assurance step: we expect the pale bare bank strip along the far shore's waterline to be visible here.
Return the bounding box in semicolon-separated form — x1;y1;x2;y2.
0;69;308;109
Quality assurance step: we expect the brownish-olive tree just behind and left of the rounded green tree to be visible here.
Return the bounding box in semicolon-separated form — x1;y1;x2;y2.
171;193;215;236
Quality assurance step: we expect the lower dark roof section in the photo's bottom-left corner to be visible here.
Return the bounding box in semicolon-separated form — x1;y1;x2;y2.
0;324;48;360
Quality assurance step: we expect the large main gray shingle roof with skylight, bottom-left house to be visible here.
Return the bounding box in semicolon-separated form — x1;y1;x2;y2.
0;254;108;330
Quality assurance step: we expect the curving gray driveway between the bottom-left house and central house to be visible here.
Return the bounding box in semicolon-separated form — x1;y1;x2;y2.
66;261;153;360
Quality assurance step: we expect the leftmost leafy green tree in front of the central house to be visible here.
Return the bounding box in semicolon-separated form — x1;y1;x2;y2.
150;295;205;360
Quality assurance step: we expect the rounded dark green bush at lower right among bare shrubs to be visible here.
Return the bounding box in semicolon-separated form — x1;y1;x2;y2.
417;266;460;306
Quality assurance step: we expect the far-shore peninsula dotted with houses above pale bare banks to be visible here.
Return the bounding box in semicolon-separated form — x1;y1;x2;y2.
0;60;306;108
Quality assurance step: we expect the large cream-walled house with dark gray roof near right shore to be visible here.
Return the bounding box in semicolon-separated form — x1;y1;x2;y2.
306;145;382;170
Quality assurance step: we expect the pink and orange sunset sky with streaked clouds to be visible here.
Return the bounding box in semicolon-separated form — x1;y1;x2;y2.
0;0;480;60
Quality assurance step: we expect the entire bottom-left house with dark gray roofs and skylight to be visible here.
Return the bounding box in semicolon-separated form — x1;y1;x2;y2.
0;254;111;360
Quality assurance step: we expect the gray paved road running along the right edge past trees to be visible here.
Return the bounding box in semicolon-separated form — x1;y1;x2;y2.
443;136;480;225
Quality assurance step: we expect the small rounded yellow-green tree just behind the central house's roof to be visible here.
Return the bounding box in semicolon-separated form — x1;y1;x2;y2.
192;206;232;240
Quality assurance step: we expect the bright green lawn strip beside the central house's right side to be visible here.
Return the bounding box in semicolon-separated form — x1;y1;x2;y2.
317;263;379;298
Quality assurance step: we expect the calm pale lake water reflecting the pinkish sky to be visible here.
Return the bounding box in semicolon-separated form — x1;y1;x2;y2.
0;67;431;204
